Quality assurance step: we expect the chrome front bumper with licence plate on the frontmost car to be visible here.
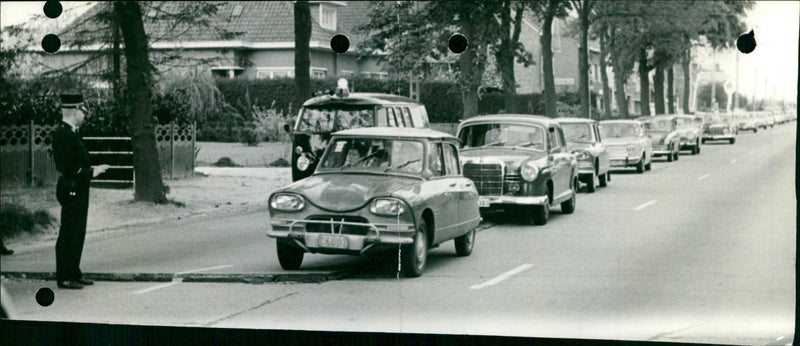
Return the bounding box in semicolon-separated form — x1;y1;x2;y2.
267;219;416;254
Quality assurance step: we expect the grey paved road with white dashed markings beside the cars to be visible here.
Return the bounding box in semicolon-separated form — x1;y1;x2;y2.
2;123;797;345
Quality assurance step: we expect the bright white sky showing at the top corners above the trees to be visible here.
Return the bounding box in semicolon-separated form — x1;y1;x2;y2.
0;0;800;100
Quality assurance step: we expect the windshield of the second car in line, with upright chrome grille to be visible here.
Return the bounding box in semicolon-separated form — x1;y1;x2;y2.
458;124;547;150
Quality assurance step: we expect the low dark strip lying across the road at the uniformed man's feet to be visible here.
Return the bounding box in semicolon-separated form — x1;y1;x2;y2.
0;270;354;284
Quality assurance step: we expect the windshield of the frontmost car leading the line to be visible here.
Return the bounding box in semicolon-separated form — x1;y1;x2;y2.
319;138;423;174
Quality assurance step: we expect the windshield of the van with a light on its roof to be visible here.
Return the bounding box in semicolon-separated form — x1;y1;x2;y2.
297;106;375;133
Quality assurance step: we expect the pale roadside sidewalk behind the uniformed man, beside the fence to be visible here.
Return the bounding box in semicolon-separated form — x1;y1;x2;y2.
2;167;292;252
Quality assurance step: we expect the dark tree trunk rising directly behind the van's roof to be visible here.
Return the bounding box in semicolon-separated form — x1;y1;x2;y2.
294;0;311;108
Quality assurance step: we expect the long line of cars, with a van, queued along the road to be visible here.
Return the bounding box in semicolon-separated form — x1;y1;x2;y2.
267;79;792;277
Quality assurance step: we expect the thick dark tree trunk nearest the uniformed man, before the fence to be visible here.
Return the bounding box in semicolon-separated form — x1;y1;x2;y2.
114;1;167;203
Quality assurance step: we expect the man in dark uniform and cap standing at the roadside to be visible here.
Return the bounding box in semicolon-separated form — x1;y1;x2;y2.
53;93;108;289
